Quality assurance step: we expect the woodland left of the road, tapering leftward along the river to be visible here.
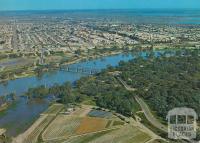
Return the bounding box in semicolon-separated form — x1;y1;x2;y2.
25;72;139;116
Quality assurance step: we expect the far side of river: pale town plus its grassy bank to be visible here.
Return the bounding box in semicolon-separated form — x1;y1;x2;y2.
0;13;200;82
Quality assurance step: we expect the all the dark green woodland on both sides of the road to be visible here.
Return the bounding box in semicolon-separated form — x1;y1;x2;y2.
27;50;200;119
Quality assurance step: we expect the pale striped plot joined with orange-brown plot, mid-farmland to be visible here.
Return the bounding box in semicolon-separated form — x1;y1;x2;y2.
42;115;109;141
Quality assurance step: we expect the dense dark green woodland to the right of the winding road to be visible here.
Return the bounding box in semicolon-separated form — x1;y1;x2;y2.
118;50;200;119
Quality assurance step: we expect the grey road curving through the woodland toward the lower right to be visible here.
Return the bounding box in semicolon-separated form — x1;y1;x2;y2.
116;76;168;133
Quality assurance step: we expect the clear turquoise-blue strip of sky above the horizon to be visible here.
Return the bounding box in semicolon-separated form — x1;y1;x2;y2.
0;0;200;10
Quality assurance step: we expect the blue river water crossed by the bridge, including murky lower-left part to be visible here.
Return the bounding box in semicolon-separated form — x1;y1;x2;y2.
0;53;138;136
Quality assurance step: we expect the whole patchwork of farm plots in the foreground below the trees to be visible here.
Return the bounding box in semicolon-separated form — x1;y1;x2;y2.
15;104;151;143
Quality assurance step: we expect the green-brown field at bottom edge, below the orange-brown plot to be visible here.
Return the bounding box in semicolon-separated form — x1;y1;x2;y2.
64;125;151;143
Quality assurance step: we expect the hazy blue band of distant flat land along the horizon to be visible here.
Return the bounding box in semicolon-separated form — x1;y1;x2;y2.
0;9;200;24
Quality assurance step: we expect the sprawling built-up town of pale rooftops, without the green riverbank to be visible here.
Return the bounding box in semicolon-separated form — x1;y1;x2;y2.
0;15;200;54
